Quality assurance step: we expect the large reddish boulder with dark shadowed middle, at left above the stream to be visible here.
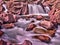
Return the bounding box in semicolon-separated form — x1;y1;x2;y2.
2;14;18;23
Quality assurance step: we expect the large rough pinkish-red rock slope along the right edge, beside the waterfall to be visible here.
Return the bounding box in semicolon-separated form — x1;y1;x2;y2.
49;2;60;24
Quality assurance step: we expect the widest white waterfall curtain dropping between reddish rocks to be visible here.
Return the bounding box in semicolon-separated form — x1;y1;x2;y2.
28;4;49;14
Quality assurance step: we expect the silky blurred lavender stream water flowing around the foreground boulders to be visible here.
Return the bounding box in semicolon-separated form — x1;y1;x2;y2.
2;19;60;45
